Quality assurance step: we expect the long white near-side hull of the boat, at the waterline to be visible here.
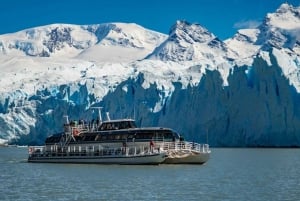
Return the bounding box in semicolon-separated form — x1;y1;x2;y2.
28;153;165;165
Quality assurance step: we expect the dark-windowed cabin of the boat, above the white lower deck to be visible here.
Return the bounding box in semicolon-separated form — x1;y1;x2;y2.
46;119;180;144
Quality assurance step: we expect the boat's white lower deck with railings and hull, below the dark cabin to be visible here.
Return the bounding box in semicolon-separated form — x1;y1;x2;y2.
28;141;210;164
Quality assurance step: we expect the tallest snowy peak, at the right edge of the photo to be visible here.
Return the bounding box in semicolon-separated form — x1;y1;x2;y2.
225;3;300;59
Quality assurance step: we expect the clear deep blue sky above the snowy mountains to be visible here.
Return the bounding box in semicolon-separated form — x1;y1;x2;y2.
0;0;300;39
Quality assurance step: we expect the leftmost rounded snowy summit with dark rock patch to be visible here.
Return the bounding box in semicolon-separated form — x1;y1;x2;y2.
0;24;97;57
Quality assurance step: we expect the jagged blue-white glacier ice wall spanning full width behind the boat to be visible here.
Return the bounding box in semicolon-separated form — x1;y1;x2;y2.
0;53;300;147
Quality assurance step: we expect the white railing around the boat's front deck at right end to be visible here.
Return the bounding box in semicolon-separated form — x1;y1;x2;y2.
163;141;210;153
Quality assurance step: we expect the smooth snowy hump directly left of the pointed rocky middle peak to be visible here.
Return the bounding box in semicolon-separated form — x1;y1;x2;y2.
77;23;167;62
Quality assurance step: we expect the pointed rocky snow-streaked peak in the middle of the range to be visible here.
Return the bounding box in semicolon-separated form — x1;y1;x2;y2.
147;21;234;65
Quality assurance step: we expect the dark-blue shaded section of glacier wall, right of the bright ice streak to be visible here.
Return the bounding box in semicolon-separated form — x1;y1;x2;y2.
159;53;300;146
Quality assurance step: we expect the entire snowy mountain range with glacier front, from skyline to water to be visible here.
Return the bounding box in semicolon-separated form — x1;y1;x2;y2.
0;4;300;147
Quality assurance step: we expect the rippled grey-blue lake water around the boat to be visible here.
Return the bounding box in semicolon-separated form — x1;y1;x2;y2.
0;147;300;201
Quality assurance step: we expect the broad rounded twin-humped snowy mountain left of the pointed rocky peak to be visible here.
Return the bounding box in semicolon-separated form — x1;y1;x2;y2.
0;23;166;62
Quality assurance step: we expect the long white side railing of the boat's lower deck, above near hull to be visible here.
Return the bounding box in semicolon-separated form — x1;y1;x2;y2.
28;146;162;158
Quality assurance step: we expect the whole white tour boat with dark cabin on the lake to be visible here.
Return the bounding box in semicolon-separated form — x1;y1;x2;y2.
28;109;211;164
